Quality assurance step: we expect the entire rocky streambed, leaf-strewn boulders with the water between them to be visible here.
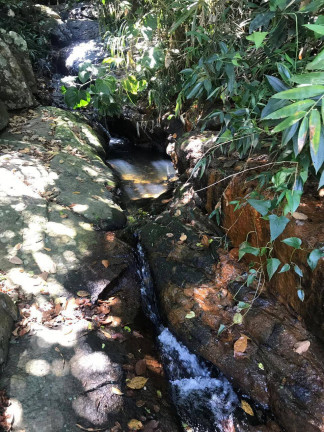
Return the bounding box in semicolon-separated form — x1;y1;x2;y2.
0;1;324;432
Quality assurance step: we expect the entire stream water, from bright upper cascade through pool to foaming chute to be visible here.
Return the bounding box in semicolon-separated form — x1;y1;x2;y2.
53;31;239;432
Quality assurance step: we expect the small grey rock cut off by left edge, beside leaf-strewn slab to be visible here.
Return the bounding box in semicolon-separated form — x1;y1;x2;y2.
0;293;18;371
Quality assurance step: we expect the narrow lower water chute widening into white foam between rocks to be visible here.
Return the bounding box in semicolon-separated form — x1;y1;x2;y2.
137;243;238;432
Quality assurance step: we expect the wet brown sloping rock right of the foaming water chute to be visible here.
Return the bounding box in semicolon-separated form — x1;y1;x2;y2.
141;198;324;432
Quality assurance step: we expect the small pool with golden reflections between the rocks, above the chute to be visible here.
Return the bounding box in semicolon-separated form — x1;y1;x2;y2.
107;146;176;200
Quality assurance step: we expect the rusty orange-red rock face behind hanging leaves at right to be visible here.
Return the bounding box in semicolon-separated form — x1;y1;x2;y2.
222;176;324;340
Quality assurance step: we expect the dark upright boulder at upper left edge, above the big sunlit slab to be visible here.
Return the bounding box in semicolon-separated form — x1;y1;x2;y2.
0;29;36;110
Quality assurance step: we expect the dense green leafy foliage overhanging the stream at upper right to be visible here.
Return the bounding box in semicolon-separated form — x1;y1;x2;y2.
61;0;324;300
